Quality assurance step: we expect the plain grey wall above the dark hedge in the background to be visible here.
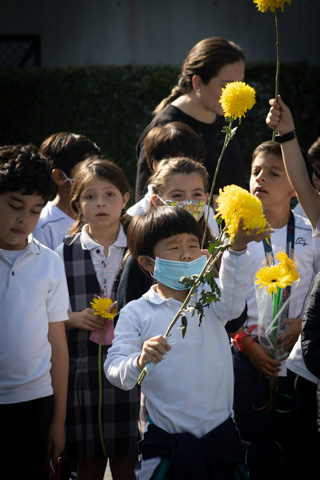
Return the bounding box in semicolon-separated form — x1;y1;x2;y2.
0;0;320;67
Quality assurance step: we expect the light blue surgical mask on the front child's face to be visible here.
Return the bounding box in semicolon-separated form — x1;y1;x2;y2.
153;255;207;290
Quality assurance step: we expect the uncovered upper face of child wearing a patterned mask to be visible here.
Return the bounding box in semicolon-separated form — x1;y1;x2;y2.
153;172;209;205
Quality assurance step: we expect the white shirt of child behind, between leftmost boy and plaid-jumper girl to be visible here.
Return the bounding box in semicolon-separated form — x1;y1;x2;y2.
33;202;74;250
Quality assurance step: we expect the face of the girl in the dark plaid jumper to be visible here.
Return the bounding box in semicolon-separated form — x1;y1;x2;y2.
77;177;129;230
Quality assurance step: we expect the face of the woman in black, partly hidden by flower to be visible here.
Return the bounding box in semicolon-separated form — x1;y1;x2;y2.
198;61;245;116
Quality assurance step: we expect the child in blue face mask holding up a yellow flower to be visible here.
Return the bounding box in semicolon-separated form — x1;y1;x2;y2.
104;207;265;480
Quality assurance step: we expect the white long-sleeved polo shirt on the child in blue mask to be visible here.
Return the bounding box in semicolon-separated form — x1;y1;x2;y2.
104;251;250;438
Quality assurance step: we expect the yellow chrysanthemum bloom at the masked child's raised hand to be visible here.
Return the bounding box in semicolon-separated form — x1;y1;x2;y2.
216;185;267;242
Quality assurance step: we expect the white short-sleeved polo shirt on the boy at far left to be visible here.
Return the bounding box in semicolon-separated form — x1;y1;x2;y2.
0;235;69;404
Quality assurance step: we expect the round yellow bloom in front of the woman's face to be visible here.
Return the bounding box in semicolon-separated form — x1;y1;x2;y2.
219;82;256;119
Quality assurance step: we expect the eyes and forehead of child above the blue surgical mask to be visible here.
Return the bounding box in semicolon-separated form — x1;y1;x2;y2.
153;233;201;262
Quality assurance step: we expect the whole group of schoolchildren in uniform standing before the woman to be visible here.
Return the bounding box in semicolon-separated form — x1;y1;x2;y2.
0;92;320;480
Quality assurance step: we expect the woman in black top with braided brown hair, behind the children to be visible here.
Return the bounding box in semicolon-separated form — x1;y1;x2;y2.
136;37;245;201
